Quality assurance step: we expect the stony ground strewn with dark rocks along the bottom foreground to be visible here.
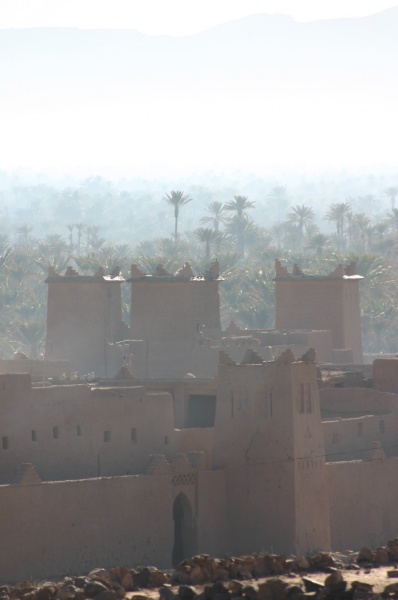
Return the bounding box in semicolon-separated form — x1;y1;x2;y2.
0;539;398;600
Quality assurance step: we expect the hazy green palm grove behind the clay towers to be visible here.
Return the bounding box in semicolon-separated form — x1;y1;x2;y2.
0;180;398;358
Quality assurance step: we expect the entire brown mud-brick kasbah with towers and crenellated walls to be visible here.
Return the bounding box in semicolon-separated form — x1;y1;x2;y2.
0;261;398;580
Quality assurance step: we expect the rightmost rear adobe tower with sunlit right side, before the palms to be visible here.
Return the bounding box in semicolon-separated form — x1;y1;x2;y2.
274;259;363;363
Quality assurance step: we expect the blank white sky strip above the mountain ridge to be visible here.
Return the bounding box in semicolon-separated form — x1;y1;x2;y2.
0;0;397;35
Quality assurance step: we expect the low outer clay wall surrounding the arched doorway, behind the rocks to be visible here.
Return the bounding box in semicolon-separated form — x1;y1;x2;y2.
0;472;225;582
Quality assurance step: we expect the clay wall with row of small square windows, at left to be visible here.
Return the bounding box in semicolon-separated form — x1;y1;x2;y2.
0;375;174;483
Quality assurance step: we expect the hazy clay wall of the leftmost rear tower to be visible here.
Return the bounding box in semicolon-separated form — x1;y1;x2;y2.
46;277;122;375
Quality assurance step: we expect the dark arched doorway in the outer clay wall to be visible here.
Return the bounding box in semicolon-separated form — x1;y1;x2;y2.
172;493;197;566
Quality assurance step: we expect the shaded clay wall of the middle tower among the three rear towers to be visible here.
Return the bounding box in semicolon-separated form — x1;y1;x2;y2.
130;278;221;378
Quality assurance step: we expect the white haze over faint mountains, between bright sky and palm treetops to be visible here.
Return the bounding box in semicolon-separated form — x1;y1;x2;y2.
0;2;398;177
